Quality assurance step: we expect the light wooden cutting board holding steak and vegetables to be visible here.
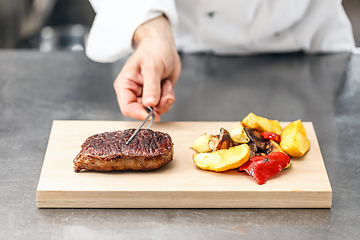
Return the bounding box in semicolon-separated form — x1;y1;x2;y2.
36;121;332;208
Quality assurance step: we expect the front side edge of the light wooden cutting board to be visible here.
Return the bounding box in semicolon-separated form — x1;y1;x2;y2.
36;191;332;208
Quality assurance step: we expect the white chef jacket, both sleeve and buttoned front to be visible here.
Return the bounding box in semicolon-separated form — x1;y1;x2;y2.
86;0;355;62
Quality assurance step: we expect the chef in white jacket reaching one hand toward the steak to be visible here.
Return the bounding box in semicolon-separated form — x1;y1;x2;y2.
86;0;355;121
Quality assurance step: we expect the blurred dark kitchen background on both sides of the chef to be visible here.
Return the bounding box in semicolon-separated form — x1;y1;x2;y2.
0;0;360;52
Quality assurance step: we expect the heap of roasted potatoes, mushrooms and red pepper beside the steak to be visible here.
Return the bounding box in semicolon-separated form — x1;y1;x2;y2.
188;113;310;185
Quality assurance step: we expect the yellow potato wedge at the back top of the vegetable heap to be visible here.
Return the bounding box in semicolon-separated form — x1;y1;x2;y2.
242;113;282;135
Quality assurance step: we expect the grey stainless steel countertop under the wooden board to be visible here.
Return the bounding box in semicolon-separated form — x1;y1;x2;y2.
0;50;360;239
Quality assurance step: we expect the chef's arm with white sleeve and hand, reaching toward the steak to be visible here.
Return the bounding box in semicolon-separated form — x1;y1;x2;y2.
86;0;181;120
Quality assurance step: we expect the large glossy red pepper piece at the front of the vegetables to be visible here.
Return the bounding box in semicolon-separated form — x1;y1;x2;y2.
239;152;290;185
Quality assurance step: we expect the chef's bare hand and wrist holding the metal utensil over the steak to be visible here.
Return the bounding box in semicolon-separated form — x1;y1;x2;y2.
114;16;181;121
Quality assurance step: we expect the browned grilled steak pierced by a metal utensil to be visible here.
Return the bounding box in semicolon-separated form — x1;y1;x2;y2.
73;129;174;172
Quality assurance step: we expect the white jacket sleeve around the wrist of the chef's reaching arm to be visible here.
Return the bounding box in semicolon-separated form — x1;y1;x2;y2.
86;0;178;63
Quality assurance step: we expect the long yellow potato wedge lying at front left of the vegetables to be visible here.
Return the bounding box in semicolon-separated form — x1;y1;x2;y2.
193;144;250;172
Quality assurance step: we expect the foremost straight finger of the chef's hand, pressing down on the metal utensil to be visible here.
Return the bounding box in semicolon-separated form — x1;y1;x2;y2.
142;64;162;107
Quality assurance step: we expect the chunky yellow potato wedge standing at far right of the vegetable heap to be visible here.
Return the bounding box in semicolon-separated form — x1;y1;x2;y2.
280;119;310;157
